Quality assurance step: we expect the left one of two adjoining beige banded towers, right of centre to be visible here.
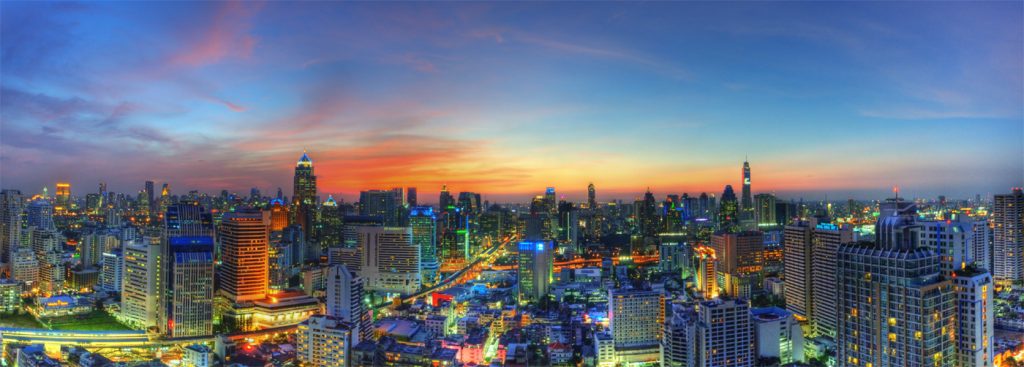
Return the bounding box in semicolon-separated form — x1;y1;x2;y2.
782;222;813;318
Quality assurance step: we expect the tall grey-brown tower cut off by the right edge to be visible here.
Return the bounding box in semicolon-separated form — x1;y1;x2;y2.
992;188;1024;284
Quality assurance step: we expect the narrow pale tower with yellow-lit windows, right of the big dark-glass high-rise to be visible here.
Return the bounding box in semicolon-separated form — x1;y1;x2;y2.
952;267;995;366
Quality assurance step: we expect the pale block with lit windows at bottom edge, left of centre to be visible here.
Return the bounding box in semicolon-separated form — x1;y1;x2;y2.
295;316;354;367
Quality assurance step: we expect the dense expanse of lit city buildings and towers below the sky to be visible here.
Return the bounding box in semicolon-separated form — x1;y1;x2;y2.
0;154;1024;367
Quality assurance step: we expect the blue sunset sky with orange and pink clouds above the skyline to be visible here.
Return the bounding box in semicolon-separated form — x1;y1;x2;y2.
0;1;1024;202
